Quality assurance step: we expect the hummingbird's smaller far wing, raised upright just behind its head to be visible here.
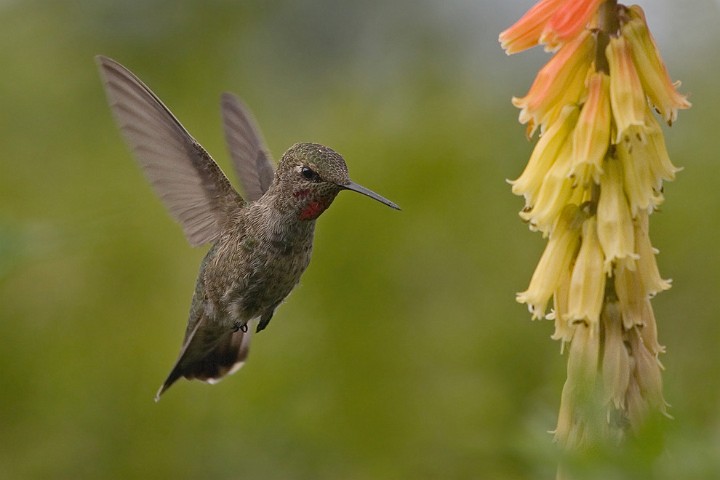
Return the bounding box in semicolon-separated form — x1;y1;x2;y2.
221;93;275;201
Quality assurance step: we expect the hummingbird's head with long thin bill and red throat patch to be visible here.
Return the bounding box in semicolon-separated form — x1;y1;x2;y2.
274;143;400;220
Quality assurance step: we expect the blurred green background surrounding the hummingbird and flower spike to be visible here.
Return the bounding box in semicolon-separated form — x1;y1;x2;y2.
0;0;720;479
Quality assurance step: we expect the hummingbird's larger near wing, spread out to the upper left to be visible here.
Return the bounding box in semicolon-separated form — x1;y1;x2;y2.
96;55;243;246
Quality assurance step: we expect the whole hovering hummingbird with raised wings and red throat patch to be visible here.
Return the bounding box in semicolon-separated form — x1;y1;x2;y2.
96;55;400;401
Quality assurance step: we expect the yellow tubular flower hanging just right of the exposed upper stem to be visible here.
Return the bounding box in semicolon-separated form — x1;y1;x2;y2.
605;37;647;143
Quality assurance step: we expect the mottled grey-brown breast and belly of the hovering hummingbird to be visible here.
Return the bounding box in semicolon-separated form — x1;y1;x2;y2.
201;203;315;328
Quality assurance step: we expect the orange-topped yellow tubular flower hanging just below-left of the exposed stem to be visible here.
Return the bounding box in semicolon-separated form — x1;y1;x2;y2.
570;72;612;186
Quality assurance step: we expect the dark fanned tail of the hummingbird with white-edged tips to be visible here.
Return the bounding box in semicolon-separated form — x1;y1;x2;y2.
155;317;252;402
